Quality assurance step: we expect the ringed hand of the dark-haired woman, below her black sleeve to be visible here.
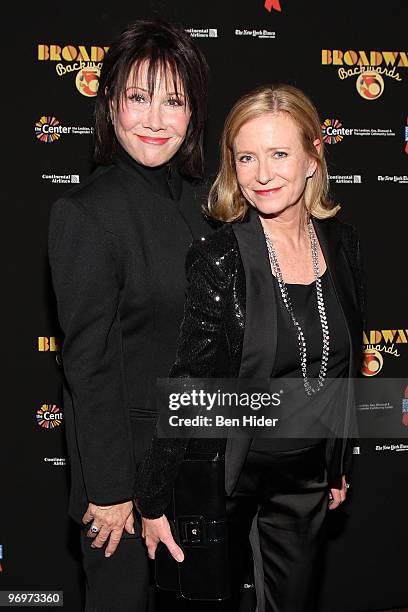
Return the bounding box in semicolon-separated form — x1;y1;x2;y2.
82;501;135;557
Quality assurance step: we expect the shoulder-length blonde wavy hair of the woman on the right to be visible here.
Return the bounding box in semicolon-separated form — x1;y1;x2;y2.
206;84;340;222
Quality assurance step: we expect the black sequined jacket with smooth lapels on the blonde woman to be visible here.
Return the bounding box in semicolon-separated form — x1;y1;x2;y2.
136;209;365;518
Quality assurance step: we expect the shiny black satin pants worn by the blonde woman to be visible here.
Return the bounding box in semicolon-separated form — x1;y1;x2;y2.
225;443;328;612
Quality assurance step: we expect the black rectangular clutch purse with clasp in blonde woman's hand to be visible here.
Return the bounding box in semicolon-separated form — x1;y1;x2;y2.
155;453;230;601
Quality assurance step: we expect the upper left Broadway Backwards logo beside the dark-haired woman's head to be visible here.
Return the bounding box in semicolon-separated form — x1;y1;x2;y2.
37;44;109;98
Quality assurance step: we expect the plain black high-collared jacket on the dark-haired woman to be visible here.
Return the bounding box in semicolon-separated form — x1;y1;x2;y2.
49;154;210;521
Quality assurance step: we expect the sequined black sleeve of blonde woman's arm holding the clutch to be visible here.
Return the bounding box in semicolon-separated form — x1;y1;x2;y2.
136;241;227;518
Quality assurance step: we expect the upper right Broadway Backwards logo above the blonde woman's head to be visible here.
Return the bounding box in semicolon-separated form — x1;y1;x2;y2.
321;49;408;100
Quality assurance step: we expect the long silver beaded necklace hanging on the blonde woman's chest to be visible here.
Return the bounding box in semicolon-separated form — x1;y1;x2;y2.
264;221;330;395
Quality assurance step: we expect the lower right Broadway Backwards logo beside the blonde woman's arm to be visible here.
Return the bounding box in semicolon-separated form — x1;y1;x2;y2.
361;329;408;376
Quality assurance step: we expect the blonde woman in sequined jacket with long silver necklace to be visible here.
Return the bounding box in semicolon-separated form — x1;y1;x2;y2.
136;84;364;612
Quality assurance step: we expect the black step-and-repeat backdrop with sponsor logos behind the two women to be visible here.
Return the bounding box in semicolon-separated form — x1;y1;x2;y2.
0;0;408;612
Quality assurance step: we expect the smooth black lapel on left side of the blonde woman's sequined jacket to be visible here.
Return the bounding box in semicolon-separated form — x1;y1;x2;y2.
225;208;277;494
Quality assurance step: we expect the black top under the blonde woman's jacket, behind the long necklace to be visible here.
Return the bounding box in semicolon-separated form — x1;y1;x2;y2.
251;269;350;452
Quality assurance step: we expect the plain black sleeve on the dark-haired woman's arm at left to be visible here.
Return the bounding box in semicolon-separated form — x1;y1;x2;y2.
48;199;135;504
